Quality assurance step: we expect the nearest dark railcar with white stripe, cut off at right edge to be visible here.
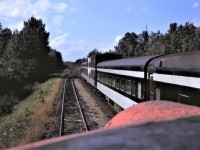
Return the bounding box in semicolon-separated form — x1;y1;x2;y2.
148;51;200;106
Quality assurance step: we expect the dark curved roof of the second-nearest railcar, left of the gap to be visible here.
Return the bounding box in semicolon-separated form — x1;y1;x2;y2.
97;55;156;68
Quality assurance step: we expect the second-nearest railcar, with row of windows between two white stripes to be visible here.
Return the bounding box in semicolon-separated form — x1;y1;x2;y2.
97;56;156;109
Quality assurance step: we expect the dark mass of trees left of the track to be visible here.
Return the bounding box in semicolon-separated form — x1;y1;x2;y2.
0;17;63;115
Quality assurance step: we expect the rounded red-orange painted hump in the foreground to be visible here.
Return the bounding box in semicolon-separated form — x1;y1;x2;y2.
105;101;200;128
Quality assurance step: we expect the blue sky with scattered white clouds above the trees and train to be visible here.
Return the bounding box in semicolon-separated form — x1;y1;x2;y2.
0;0;200;61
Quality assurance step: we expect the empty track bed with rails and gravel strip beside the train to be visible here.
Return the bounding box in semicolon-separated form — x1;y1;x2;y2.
59;76;116;136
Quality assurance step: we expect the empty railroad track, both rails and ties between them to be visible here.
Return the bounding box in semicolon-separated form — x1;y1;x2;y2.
59;76;88;136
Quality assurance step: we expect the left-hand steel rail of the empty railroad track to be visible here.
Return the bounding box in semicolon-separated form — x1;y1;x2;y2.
59;79;67;136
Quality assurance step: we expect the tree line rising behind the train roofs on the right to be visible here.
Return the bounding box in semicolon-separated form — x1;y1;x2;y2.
114;22;200;58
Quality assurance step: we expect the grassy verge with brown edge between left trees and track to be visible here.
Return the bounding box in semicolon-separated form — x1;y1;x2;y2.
0;78;61;149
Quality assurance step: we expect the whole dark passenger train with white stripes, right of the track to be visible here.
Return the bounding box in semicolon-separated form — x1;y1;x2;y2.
81;51;200;111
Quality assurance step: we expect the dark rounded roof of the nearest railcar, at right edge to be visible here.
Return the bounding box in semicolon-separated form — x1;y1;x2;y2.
149;51;200;72
